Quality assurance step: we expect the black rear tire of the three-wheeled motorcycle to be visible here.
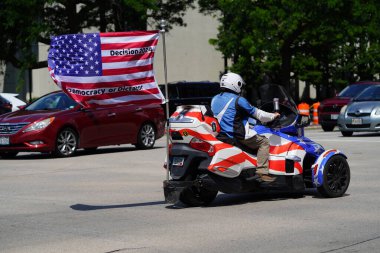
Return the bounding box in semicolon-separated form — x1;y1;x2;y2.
179;186;218;206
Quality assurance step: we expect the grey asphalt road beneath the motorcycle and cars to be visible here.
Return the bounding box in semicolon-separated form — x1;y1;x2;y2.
0;129;380;253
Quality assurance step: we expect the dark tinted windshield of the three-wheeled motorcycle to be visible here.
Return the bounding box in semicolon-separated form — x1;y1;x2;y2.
258;84;297;112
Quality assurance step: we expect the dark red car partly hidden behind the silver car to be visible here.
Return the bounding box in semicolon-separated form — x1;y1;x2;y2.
318;81;380;131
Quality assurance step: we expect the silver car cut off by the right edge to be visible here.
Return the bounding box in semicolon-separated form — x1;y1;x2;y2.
338;85;380;136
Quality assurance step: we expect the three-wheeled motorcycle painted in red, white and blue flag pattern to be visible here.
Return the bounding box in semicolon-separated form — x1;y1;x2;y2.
163;86;350;206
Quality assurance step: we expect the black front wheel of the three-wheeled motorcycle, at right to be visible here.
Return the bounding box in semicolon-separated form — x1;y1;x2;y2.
317;155;351;198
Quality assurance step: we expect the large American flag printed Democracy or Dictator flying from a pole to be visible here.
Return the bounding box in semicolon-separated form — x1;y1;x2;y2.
48;31;164;106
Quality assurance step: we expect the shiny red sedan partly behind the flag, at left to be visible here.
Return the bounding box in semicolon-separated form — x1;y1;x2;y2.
0;91;165;158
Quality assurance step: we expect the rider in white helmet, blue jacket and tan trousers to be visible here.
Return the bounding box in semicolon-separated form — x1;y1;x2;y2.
211;72;280;182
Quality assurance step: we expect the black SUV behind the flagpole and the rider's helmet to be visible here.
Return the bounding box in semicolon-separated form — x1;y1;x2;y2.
159;81;220;115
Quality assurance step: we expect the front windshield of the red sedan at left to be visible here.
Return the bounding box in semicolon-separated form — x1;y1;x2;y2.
25;92;77;111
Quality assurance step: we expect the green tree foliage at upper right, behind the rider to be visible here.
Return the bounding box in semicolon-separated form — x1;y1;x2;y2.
199;0;380;101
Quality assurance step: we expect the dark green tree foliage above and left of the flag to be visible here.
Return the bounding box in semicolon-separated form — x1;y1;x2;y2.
0;0;194;69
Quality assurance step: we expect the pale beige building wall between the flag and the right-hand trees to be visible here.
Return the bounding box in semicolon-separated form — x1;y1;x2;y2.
154;6;224;83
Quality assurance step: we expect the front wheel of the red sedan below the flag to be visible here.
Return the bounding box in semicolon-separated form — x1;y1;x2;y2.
54;128;78;157
